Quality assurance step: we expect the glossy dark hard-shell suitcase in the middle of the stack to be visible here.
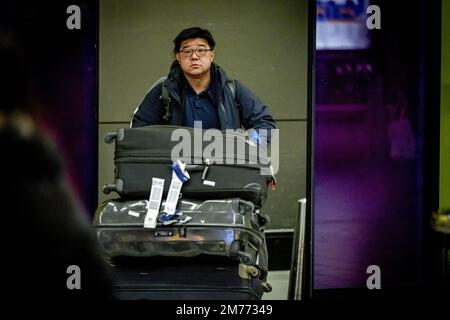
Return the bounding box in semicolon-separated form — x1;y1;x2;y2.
93;198;269;268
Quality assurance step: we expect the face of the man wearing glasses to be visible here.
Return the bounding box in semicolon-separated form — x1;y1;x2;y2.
176;38;214;78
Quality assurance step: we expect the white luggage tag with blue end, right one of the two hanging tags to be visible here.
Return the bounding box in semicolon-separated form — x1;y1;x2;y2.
163;159;190;220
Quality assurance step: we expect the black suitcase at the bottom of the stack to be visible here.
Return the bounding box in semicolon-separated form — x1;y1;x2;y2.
113;256;264;300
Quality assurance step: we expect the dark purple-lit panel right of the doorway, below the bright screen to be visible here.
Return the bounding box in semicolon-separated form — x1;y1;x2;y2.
313;1;424;289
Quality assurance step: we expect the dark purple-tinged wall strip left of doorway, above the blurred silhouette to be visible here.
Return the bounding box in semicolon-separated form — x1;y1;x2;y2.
2;0;98;215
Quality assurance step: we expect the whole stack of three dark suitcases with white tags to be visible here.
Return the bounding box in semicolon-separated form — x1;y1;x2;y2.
94;126;274;299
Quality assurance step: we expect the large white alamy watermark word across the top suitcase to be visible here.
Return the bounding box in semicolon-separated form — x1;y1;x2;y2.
171;121;280;176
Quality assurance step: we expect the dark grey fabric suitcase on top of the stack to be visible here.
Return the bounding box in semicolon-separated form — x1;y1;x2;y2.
103;125;275;207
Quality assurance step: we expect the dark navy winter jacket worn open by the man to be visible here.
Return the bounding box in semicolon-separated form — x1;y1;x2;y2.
131;61;276;130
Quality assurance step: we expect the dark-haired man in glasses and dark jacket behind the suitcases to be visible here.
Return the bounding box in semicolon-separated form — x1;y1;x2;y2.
131;27;275;141
